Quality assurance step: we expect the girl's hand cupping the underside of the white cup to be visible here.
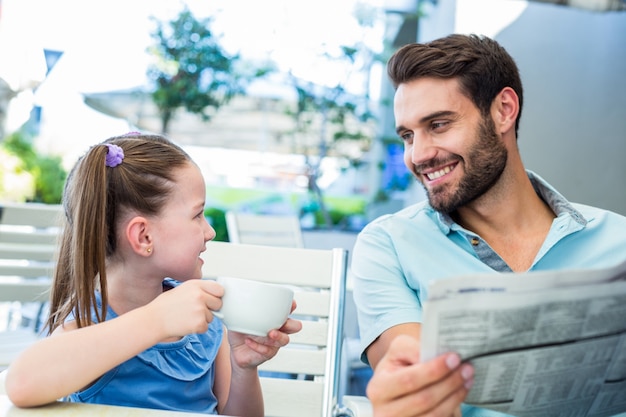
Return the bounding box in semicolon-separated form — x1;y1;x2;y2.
228;301;302;368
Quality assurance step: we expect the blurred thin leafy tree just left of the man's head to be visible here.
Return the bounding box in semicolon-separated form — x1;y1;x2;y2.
288;5;383;227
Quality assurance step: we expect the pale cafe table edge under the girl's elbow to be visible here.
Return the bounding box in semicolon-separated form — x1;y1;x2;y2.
0;395;225;417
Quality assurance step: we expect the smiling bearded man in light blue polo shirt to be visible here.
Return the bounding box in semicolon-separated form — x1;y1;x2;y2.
352;35;626;417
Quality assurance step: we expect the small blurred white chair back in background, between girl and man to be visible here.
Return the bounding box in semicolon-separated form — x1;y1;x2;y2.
226;211;304;248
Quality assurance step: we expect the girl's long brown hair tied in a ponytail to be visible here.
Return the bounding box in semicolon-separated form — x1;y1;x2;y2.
47;133;191;333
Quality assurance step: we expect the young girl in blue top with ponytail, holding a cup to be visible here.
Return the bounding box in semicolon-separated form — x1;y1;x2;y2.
6;133;301;416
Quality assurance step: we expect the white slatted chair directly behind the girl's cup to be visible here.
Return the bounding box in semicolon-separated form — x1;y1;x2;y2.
202;241;368;417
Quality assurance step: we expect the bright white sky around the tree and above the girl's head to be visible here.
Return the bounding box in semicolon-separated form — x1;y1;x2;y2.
0;0;382;167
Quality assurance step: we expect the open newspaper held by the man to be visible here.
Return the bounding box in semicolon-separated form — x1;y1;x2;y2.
421;262;626;417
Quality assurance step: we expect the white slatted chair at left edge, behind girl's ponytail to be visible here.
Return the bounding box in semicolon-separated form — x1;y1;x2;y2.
0;203;62;370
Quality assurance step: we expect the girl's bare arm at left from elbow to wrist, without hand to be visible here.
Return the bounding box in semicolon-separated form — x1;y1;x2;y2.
5;308;162;407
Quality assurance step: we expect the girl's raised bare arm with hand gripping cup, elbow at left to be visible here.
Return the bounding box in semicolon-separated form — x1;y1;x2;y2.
5;280;221;407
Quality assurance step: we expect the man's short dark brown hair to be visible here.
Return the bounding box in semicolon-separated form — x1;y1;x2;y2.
387;34;523;136
